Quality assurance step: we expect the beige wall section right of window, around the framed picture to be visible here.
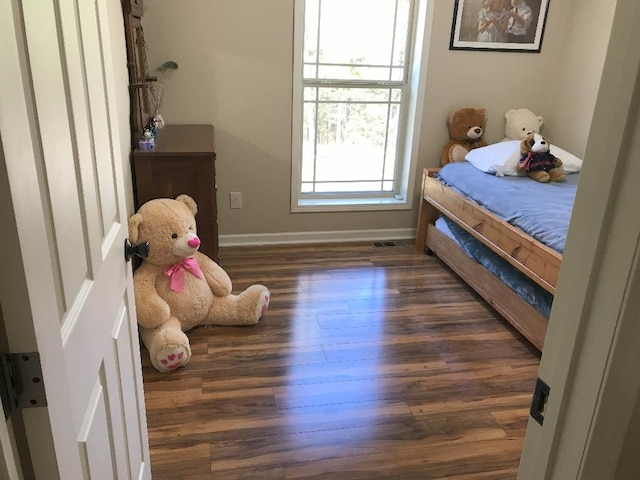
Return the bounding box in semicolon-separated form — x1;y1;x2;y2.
421;1;565;152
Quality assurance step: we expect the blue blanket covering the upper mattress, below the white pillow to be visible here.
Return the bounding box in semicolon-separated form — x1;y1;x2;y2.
440;162;579;253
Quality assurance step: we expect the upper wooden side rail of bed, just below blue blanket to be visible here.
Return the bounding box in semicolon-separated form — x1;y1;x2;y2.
421;172;562;293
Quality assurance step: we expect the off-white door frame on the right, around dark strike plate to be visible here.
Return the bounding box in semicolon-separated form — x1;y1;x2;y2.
518;0;640;480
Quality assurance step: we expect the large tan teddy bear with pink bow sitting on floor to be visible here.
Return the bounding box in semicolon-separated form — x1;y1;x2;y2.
129;195;270;372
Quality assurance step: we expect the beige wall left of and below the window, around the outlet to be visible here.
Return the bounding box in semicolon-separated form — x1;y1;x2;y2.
143;0;415;235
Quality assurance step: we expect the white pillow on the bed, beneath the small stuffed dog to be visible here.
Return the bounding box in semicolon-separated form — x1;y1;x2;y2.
465;140;582;177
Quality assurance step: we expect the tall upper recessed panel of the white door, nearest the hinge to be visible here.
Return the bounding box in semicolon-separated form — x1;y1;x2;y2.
23;2;87;311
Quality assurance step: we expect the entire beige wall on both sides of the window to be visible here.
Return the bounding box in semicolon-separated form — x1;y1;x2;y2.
143;0;612;243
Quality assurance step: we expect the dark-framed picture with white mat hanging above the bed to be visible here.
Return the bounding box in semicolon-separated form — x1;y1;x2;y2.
449;0;549;53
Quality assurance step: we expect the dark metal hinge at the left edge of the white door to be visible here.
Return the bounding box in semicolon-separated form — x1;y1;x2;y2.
0;352;47;420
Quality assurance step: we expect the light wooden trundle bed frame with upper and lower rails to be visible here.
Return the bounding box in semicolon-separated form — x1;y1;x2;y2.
416;168;562;350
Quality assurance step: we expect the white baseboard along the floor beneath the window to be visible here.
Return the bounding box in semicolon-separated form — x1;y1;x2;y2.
218;228;416;247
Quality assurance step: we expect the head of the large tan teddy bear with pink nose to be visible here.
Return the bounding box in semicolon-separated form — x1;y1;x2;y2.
129;195;200;266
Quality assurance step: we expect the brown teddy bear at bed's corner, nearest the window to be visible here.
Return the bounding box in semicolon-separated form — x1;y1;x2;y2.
440;108;487;166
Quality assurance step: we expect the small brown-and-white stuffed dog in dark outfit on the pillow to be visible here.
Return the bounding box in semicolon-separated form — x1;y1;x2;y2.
516;133;565;183
